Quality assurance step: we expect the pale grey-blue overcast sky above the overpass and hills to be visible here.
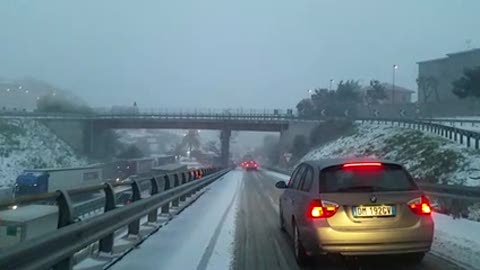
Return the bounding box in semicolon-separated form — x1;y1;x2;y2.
0;0;480;108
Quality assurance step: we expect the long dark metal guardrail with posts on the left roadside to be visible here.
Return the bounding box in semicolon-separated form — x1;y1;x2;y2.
0;169;230;270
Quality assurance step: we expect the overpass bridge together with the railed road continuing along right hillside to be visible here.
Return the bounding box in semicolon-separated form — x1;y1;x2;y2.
0;110;480;165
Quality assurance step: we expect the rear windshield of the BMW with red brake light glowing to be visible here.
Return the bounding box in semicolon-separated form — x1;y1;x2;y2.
320;164;418;193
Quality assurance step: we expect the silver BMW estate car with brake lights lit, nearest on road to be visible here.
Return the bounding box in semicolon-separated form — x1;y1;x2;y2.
275;159;434;265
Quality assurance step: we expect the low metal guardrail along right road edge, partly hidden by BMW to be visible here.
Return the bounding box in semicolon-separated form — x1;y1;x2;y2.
266;167;480;201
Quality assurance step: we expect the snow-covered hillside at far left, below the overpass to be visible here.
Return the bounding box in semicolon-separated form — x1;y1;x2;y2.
0;119;87;186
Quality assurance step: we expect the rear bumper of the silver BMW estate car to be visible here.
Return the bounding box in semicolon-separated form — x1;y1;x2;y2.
302;221;433;255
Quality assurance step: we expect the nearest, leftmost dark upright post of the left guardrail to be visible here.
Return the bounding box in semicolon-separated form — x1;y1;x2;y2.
53;190;74;270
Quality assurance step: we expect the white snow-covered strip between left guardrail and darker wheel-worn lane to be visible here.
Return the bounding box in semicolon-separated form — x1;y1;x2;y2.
112;171;242;270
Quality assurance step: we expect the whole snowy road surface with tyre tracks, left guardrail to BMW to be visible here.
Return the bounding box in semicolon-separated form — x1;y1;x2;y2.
109;170;468;270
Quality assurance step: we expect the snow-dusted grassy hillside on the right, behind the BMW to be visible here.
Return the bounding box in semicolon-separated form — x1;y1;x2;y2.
303;124;480;186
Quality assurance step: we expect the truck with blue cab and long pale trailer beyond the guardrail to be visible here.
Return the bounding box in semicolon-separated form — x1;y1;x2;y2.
15;164;103;197
